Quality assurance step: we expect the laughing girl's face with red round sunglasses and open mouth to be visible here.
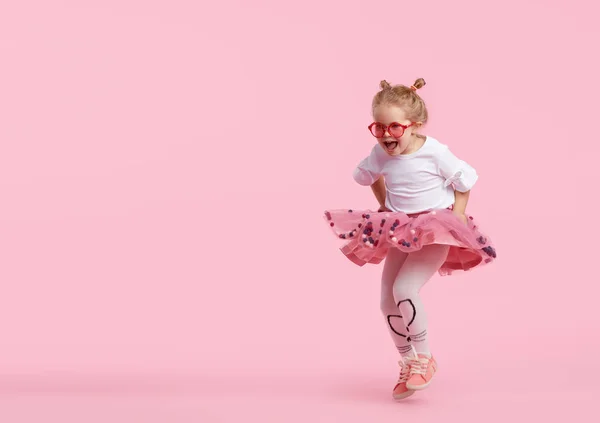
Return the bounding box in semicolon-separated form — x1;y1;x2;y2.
371;104;416;156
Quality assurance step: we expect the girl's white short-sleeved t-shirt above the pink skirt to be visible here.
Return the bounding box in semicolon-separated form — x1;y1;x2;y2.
353;137;478;214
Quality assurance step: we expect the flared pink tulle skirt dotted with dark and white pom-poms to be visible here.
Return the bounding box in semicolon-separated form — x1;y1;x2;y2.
324;209;496;275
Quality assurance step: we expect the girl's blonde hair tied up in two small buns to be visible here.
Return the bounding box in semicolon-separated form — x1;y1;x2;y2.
372;78;429;124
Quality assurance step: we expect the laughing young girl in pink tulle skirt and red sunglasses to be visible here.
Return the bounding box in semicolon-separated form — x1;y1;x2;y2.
325;79;496;399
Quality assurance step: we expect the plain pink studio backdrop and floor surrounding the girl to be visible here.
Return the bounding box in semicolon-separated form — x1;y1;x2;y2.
0;0;600;423
